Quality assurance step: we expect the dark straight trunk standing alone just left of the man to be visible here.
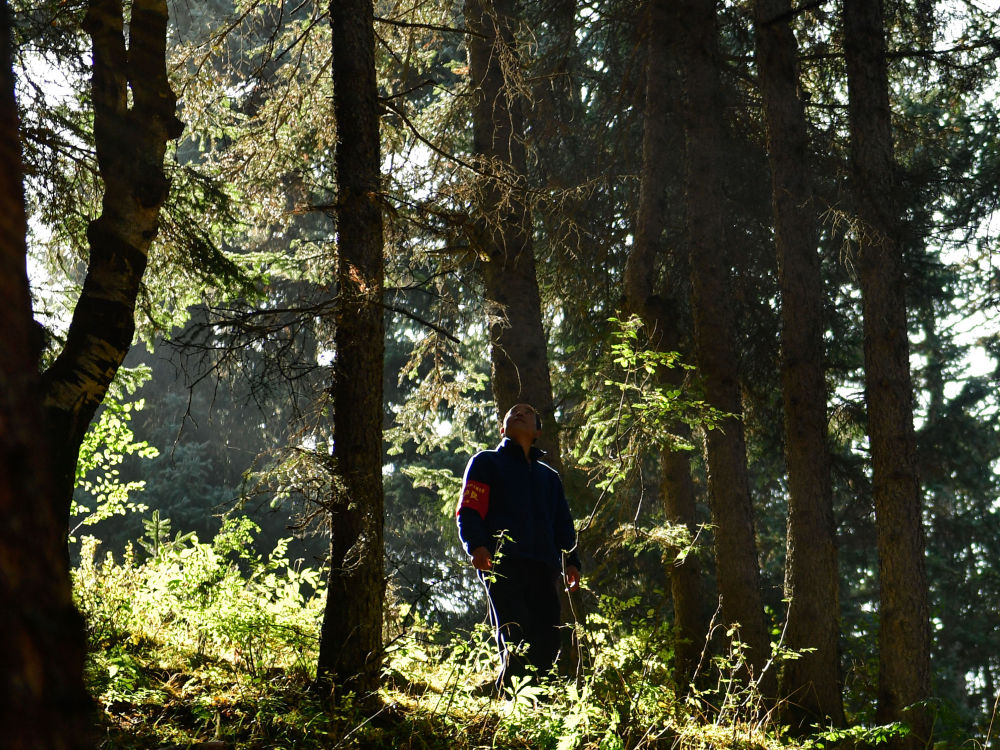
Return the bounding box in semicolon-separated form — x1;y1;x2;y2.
317;0;385;695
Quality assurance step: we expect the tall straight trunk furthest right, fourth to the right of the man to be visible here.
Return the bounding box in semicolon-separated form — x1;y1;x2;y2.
844;0;930;747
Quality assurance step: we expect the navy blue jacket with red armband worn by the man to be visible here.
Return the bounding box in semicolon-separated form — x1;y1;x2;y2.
456;438;580;570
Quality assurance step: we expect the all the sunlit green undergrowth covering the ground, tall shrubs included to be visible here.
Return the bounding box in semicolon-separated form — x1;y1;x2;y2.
75;519;916;750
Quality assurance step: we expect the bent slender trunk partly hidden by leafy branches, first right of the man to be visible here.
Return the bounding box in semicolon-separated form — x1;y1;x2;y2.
625;0;708;685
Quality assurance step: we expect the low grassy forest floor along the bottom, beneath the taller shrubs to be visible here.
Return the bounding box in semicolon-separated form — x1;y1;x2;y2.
89;634;844;750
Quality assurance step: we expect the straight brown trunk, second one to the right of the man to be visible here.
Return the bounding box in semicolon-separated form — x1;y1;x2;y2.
677;0;774;694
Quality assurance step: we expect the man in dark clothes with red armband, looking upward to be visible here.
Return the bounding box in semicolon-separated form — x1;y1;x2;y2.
456;404;580;689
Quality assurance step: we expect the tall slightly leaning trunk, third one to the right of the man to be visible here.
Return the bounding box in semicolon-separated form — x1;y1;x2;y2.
754;0;844;729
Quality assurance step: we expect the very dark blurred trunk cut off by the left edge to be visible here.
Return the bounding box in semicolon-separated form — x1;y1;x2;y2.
0;0;93;750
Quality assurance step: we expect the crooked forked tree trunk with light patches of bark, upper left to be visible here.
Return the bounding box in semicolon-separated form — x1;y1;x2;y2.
42;0;183;533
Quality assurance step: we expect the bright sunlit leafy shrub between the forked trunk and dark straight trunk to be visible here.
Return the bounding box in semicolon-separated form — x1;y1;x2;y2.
75;518;324;677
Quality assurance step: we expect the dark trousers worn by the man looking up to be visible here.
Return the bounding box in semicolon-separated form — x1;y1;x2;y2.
480;557;560;686
